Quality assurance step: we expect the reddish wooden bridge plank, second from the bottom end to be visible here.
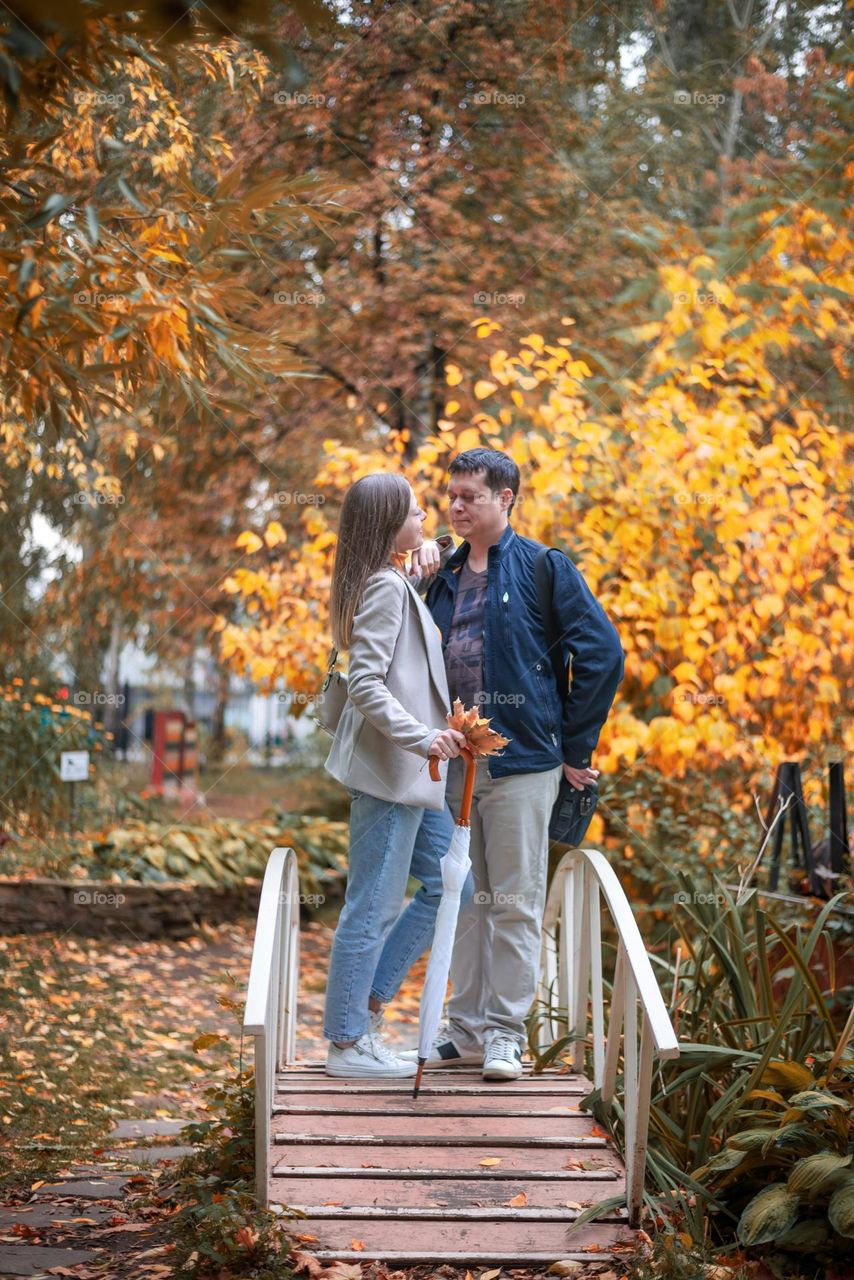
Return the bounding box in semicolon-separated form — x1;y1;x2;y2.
270;1169;625;1217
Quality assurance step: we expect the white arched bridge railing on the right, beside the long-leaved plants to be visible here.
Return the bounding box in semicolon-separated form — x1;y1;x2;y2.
538;849;679;1226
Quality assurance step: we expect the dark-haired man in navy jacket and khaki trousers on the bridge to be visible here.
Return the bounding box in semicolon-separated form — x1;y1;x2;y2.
403;448;625;1080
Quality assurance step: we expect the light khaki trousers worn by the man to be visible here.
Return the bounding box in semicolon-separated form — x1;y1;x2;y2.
446;758;562;1052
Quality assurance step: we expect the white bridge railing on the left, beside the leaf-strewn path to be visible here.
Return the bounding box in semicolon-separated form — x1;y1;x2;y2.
243;849;300;1206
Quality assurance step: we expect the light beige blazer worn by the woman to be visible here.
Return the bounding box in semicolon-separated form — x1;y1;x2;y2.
325;560;453;809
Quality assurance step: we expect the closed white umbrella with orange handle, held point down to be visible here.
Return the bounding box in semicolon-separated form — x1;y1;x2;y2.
412;746;475;1098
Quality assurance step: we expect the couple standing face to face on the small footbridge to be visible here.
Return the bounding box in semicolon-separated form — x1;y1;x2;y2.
324;448;624;1080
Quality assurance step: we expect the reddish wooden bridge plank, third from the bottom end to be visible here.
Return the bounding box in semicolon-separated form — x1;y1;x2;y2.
271;1138;622;1172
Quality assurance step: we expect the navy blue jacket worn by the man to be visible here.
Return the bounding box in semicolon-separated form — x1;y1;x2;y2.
426;525;625;778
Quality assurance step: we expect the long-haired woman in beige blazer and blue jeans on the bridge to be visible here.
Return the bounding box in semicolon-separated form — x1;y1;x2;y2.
324;472;474;1076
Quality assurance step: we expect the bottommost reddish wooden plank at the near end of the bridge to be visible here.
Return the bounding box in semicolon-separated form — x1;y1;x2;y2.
280;1217;634;1263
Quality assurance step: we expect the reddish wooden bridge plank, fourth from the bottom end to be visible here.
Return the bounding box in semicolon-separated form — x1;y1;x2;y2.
273;1108;604;1142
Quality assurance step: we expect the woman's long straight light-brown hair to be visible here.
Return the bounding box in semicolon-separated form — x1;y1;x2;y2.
329;471;412;649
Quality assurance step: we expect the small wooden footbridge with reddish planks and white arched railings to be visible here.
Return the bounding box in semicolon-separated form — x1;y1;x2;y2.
243;849;679;1266
